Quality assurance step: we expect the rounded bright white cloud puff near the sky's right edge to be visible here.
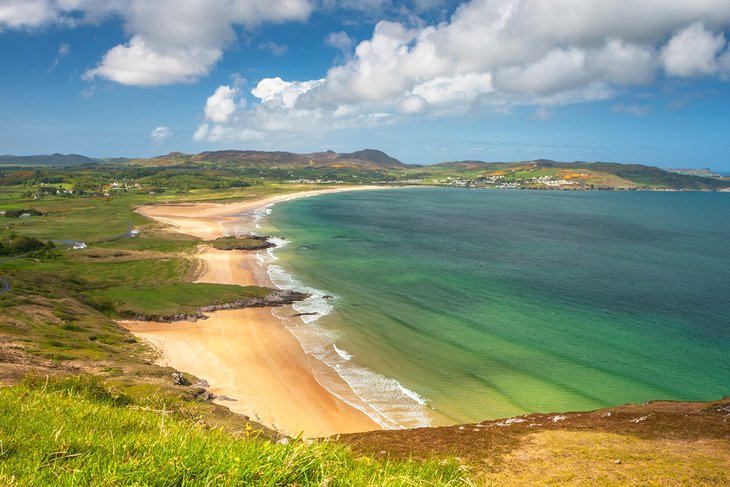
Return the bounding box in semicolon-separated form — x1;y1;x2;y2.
662;22;725;78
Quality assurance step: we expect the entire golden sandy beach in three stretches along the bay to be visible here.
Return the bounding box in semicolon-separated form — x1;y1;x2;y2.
121;187;380;437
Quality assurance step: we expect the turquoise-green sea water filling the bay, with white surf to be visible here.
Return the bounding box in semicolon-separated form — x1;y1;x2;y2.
266;188;730;426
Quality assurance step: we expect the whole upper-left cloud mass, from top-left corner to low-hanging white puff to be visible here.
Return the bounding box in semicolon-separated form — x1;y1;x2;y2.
0;0;312;86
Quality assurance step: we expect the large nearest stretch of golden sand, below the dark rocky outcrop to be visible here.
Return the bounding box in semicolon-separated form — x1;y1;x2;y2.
124;308;379;437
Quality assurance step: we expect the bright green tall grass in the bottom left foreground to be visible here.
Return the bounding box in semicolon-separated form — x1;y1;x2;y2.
0;376;468;486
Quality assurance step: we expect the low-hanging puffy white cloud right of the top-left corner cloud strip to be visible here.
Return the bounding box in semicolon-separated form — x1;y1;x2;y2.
85;0;311;86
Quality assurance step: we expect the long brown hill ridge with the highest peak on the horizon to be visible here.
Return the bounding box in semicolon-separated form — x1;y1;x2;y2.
135;149;408;170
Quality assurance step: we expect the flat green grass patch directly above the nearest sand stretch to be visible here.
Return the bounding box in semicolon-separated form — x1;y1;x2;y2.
89;283;269;317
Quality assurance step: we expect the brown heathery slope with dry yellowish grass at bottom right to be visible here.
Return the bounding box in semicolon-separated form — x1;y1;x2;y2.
338;398;730;485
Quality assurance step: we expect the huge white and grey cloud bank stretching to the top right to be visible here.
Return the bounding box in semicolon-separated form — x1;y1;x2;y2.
192;0;730;143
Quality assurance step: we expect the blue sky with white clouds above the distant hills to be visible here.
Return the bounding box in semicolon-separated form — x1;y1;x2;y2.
0;0;730;171
